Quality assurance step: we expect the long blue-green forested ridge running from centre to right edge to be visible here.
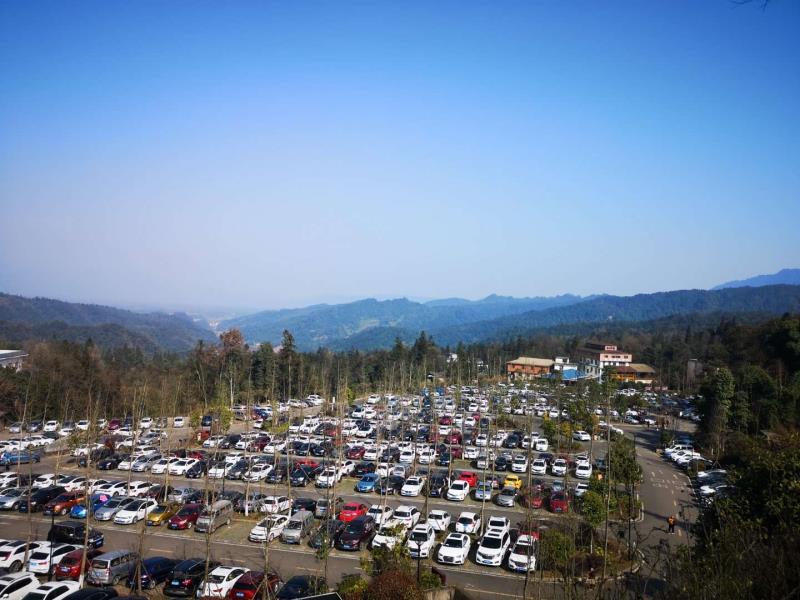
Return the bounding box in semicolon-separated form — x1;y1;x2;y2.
219;285;800;350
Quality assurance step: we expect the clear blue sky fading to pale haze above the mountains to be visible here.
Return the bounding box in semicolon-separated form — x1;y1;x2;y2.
0;0;800;308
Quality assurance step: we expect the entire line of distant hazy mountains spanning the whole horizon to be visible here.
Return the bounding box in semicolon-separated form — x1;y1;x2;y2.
0;269;800;352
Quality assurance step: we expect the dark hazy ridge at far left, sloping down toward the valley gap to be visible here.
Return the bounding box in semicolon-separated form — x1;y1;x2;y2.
0;293;216;352
